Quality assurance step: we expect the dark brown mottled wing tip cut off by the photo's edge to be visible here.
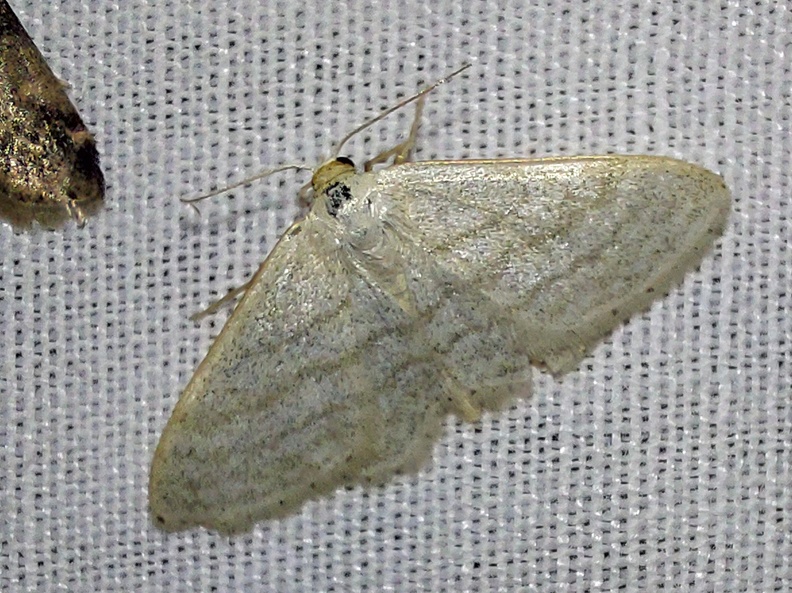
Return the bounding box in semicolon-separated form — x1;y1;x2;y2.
0;0;105;228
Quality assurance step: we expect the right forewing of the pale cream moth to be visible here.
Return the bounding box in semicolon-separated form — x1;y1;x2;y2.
377;155;731;374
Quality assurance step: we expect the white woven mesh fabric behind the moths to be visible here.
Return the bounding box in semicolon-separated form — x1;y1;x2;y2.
0;0;792;592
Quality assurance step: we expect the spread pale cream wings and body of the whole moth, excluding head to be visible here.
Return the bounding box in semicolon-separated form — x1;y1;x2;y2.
150;157;729;533
